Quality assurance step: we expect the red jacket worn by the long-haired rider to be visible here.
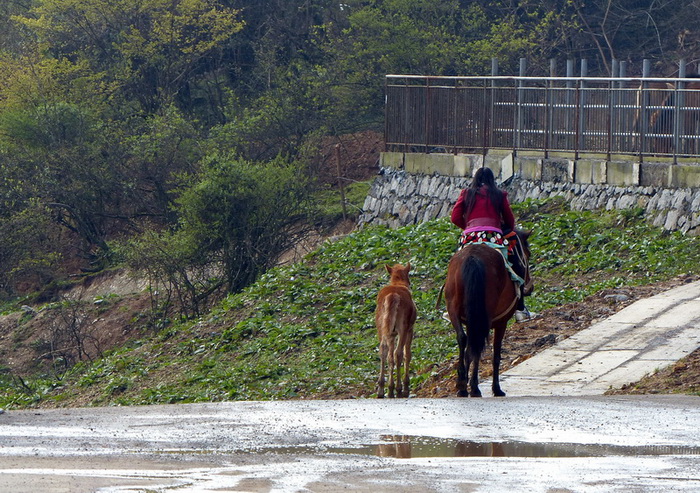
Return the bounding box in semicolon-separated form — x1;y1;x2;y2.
451;187;515;233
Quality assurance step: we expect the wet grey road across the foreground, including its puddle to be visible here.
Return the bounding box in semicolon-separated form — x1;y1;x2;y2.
0;396;700;493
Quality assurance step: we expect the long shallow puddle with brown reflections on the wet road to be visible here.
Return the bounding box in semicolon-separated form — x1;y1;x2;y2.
266;435;700;459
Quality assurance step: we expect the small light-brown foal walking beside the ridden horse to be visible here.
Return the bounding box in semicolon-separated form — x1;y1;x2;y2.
375;263;417;399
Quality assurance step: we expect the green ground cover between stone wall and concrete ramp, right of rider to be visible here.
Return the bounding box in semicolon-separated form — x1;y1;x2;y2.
514;200;700;311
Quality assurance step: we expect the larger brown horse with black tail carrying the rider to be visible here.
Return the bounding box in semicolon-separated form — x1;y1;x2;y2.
445;231;532;397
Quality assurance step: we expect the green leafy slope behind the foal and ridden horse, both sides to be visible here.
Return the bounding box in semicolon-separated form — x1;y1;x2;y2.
0;196;700;407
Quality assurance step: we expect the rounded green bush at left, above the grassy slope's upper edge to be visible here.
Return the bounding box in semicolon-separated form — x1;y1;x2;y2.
177;155;307;292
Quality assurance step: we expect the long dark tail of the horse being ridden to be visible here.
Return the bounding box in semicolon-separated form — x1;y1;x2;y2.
462;256;490;358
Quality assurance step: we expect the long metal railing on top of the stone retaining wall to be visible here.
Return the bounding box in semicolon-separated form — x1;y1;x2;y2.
385;75;700;160
